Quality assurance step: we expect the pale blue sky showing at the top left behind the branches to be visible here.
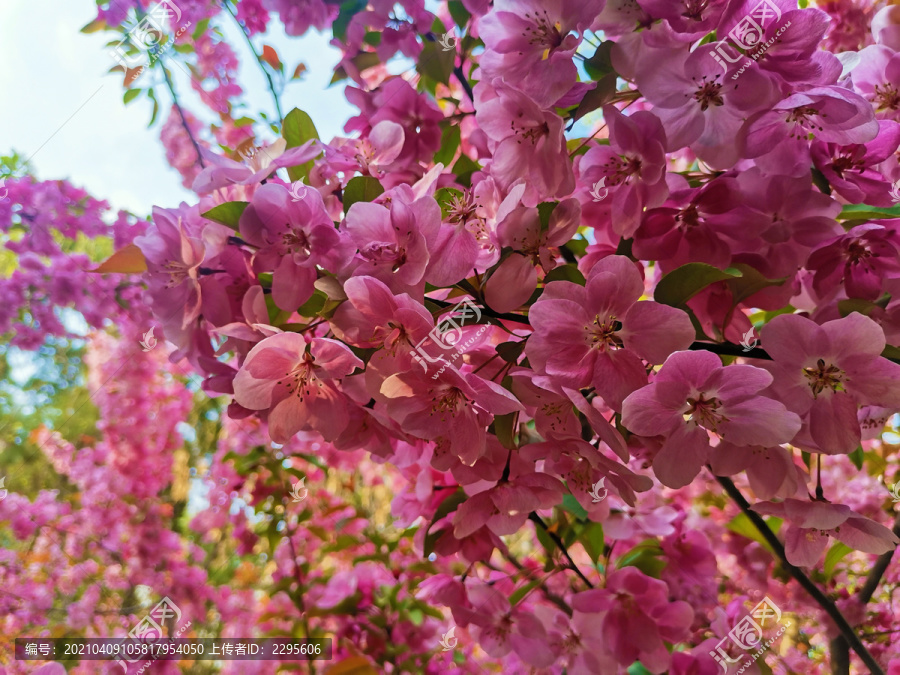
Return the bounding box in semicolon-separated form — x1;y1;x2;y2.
0;0;355;216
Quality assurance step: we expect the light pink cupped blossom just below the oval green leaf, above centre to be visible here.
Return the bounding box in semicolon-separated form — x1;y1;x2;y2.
344;197;441;292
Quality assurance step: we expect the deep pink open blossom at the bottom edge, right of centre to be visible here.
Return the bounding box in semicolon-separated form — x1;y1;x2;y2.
572;567;694;673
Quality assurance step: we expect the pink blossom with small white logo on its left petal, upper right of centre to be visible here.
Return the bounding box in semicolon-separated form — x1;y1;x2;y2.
578;105;669;238
